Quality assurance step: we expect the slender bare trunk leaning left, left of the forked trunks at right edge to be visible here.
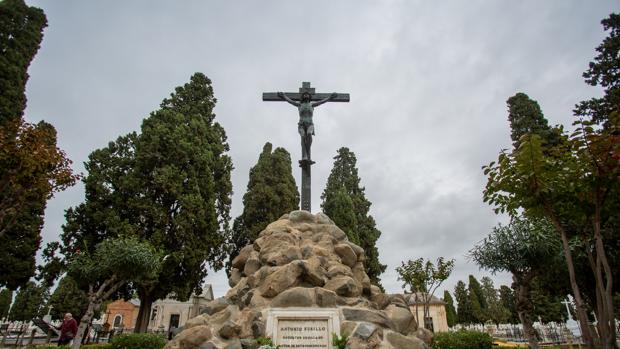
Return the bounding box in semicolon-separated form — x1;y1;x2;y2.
546;208;595;348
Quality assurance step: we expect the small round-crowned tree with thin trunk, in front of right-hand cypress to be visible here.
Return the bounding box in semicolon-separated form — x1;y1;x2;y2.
469;217;560;349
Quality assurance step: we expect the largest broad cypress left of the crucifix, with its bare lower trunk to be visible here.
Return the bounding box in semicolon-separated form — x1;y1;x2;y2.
133;73;233;332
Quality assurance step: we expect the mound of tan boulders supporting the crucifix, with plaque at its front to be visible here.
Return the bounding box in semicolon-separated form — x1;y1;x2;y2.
166;211;432;349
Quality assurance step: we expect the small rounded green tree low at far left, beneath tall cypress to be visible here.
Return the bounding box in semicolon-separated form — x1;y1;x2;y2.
9;281;48;321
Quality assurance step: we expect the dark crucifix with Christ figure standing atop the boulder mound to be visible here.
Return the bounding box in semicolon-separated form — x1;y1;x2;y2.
263;82;349;211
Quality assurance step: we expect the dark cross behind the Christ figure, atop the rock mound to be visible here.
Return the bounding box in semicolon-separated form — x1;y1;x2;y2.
263;81;349;212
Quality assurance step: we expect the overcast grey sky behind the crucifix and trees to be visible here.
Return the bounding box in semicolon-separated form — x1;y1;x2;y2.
26;0;618;297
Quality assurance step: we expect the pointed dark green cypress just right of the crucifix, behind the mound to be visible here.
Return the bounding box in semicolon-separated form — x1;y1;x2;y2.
321;147;386;285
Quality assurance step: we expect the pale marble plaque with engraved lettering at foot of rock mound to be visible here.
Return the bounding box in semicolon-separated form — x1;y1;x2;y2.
266;308;340;349
